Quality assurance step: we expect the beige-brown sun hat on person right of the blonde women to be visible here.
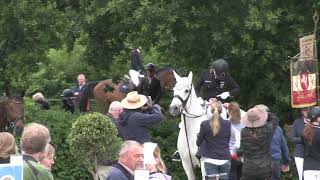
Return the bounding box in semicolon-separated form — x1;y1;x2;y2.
241;107;268;128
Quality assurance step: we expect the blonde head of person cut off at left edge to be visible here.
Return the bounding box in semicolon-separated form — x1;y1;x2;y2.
0;132;17;164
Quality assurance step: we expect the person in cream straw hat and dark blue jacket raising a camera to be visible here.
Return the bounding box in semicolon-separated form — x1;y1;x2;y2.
117;91;163;144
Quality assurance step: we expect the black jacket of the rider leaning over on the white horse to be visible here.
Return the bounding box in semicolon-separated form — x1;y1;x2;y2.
195;71;240;101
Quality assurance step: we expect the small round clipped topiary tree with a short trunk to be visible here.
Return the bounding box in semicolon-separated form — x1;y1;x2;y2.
67;113;121;180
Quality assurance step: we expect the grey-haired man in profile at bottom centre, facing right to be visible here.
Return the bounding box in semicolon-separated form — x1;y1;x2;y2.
106;141;143;180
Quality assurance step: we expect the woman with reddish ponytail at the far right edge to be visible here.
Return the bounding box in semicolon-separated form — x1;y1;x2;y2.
303;106;320;180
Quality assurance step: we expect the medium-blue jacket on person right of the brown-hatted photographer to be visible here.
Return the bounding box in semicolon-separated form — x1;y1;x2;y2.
271;126;290;165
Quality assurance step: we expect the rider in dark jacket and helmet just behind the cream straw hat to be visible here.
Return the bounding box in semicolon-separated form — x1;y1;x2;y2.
138;63;161;104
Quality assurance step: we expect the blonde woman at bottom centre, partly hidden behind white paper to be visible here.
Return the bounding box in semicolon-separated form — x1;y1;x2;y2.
144;142;172;180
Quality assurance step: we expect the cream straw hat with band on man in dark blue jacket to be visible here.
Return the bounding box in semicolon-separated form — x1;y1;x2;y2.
121;91;148;109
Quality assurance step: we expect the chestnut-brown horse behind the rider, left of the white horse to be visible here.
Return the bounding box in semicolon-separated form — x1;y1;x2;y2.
93;67;176;112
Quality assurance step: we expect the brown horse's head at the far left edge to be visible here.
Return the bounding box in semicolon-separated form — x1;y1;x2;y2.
0;96;24;134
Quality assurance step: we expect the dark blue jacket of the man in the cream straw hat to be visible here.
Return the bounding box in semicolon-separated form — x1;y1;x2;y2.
118;107;162;144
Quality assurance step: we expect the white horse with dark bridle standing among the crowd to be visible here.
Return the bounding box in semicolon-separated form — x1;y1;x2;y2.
170;72;207;180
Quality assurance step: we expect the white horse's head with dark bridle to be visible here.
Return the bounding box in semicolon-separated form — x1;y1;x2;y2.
169;71;193;116
